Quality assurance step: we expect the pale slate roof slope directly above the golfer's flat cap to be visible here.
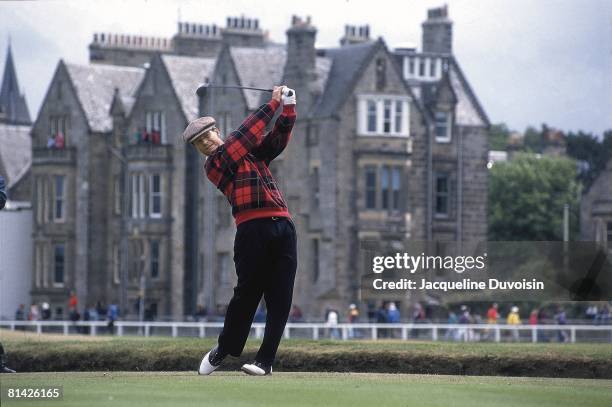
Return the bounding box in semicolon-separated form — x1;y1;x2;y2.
161;55;216;121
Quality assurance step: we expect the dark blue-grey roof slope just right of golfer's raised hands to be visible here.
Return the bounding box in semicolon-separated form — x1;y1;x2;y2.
312;41;382;117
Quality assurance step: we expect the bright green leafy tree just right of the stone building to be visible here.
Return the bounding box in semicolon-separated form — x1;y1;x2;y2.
488;154;579;241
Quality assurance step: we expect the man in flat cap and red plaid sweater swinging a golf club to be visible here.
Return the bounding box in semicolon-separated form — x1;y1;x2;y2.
183;86;297;376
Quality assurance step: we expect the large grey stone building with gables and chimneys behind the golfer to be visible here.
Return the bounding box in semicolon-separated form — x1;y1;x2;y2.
32;7;488;319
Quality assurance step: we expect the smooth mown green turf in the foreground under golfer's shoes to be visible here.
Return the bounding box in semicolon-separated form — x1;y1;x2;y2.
1;372;612;407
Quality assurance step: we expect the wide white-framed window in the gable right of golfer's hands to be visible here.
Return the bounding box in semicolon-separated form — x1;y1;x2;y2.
357;95;409;137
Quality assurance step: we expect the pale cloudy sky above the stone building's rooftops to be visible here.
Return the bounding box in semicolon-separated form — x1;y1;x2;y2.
0;0;612;134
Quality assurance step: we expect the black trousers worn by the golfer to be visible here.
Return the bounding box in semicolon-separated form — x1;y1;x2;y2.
219;218;297;365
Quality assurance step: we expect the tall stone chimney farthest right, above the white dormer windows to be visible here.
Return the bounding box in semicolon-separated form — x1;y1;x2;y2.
422;4;453;54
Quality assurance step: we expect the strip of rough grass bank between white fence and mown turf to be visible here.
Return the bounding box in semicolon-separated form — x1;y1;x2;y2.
0;331;612;379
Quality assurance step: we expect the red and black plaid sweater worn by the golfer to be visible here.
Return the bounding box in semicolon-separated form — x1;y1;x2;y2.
204;100;296;225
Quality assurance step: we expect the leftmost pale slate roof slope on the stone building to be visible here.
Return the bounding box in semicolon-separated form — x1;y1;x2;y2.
65;63;145;132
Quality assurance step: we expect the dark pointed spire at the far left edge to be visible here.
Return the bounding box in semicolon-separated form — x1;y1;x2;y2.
0;44;32;125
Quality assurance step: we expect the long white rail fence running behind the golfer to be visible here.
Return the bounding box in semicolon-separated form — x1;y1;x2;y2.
0;321;612;343
